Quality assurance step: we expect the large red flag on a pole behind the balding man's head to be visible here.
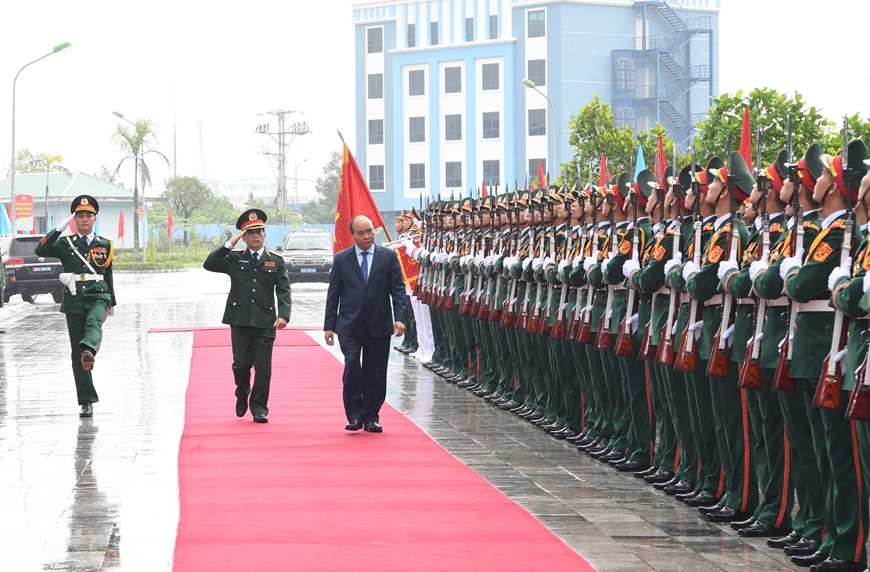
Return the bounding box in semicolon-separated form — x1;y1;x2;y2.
333;143;392;252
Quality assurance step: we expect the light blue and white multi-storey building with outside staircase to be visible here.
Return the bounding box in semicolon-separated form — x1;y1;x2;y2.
353;0;721;218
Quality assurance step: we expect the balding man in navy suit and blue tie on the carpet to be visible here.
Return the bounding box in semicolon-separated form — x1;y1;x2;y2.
323;215;405;433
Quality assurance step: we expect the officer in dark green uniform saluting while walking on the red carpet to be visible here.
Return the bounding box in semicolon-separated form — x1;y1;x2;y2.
202;209;291;423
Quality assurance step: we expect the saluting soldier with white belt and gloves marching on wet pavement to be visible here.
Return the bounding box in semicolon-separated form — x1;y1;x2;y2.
34;195;117;417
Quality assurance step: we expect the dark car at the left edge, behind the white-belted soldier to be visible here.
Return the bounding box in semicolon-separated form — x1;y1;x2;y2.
0;234;63;303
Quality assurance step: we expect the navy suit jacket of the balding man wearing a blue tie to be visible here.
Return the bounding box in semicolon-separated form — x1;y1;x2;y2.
323;245;405;338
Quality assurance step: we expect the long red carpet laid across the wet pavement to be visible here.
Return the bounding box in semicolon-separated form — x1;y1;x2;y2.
174;330;593;572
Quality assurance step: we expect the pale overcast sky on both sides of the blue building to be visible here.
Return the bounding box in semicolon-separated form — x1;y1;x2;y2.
0;0;870;201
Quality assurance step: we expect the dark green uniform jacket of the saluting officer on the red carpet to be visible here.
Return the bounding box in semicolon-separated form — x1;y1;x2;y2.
202;246;292;329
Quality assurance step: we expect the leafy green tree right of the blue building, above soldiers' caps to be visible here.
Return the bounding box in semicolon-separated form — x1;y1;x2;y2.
695;87;832;167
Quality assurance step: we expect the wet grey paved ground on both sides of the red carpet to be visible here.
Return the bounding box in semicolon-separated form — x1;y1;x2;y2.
0;269;832;572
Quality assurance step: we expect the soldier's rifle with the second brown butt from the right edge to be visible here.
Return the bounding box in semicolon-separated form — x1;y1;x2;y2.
813;117;855;409
